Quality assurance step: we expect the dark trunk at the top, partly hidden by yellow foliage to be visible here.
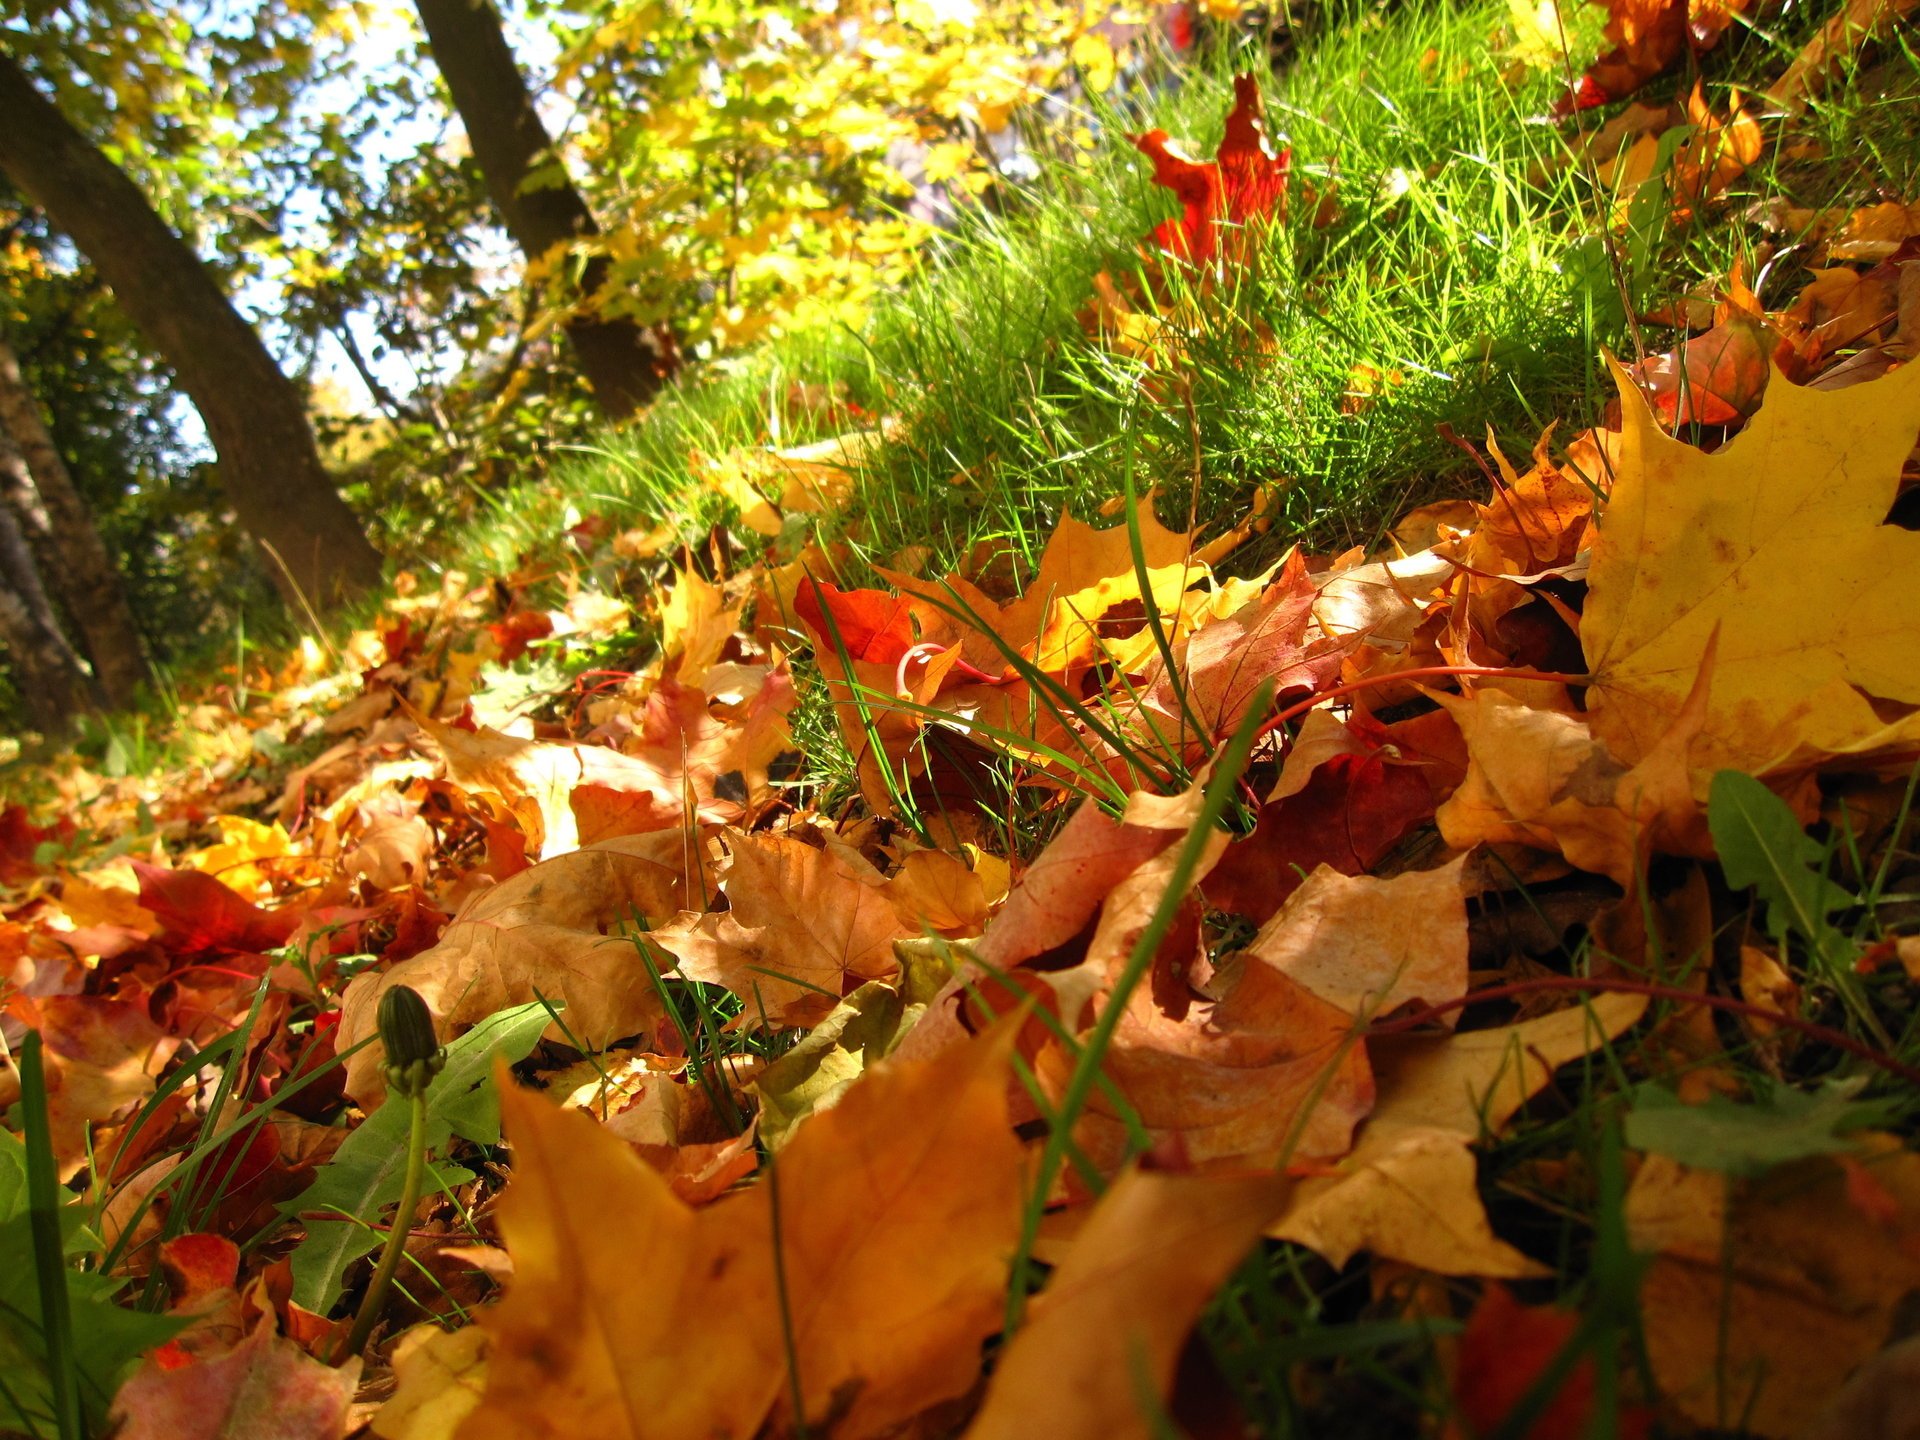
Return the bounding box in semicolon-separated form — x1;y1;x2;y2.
415;0;668;420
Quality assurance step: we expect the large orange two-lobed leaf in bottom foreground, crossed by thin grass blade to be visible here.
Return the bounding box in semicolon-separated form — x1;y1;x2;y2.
459;1031;1023;1440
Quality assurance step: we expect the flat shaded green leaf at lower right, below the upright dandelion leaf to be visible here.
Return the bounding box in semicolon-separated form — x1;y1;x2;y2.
1626;1081;1889;1175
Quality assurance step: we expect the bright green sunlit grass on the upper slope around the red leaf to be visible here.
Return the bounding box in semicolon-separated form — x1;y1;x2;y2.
449;4;1920;614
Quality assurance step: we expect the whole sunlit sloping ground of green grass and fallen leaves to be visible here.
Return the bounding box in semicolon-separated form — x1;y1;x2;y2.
0;4;1920;1440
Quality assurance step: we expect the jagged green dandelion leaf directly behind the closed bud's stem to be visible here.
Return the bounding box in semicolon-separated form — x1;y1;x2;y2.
282;1002;553;1315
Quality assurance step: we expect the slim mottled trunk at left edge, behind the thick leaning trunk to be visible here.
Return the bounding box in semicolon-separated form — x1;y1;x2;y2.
0;340;150;707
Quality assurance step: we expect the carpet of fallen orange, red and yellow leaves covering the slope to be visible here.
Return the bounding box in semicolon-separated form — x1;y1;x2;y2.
0;30;1920;1440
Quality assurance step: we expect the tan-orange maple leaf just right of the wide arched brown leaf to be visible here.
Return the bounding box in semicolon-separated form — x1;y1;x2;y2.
653;829;920;1025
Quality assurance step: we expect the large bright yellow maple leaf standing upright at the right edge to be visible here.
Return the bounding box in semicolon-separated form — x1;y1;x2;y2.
1580;365;1920;774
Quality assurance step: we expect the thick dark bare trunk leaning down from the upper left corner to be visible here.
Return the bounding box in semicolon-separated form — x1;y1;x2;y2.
0;52;380;605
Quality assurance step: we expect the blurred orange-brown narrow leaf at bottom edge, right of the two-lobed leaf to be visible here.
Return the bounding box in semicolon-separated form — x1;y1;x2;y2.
966;1169;1290;1440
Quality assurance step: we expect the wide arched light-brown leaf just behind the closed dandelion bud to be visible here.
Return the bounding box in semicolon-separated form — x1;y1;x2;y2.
338;835;687;1110
